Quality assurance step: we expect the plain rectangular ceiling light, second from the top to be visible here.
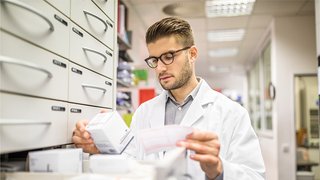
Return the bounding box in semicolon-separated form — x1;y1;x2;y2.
208;29;245;42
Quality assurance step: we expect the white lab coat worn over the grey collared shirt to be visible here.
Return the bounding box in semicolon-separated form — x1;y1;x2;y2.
125;80;265;180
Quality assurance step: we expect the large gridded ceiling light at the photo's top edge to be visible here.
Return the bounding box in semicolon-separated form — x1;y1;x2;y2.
205;0;255;17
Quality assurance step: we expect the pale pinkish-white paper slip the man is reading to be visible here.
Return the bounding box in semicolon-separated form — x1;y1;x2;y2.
136;125;193;154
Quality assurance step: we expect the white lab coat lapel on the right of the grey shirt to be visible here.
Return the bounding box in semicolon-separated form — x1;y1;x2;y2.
180;80;215;126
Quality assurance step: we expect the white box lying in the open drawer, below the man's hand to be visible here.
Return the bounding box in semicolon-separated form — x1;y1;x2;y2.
28;148;82;173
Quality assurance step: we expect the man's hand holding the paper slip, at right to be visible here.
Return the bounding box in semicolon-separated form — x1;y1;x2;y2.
177;130;223;179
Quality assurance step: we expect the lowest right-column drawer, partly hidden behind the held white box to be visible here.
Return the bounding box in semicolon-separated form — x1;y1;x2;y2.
68;103;111;143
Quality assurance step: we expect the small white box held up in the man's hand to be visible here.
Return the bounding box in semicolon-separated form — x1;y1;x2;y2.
86;111;133;154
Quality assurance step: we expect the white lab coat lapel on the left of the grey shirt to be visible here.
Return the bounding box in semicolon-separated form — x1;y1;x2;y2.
150;91;167;128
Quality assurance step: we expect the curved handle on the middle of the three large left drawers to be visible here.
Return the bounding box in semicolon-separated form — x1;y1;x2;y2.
0;56;52;78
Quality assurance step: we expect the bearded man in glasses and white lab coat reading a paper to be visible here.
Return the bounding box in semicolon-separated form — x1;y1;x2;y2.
73;17;265;180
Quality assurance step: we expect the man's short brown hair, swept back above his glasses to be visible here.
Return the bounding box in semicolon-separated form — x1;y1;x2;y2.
146;17;194;46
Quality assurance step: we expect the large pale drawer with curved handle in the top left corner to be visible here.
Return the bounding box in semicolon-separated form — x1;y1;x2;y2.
0;0;70;58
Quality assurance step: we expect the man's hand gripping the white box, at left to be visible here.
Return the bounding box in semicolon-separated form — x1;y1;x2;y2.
72;120;100;154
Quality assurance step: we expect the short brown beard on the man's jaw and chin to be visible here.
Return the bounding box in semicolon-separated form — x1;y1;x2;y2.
159;58;192;90
